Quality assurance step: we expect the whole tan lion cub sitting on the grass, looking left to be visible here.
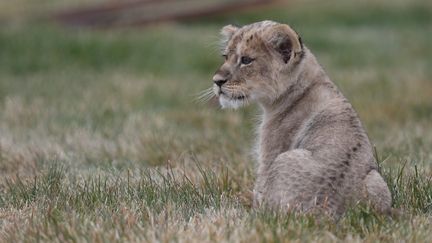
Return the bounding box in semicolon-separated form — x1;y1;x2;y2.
213;21;391;217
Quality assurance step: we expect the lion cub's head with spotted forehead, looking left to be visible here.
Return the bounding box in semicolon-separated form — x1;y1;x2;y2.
213;21;303;108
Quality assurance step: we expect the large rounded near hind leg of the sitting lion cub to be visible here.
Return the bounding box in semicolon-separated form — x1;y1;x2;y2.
254;149;342;214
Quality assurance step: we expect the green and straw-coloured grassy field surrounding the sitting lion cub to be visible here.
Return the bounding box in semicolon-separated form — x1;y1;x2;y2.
0;0;432;242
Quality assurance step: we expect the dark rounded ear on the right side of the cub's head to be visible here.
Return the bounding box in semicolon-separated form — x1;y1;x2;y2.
266;24;303;63
